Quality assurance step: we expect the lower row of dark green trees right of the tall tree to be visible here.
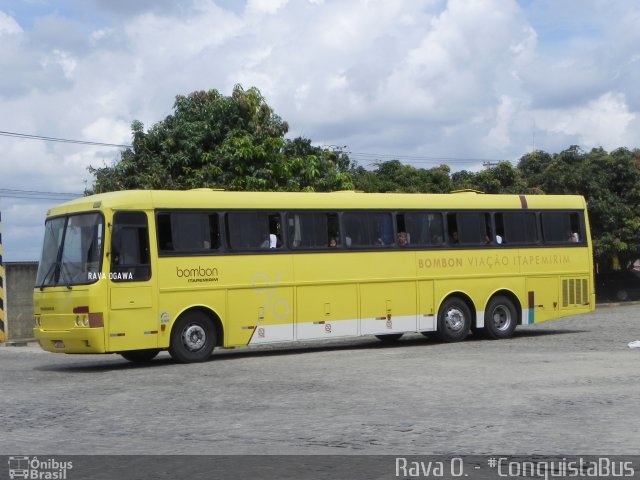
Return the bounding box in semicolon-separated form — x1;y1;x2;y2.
353;145;640;267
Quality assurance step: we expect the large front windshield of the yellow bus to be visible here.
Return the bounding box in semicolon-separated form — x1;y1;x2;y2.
36;213;104;288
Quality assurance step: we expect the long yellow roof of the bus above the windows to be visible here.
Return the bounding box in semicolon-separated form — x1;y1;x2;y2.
48;188;585;216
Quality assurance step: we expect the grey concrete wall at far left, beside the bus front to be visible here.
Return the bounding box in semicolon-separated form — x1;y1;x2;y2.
4;262;38;342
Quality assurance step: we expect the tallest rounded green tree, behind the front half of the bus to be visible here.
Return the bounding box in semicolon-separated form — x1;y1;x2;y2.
89;85;353;193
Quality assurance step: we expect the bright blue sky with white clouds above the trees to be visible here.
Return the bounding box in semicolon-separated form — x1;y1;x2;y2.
0;0;640;262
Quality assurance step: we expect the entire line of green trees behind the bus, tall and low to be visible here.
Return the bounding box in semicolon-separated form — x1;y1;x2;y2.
87;85;640;265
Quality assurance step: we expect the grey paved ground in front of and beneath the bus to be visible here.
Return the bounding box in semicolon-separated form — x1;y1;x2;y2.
0;305;640;455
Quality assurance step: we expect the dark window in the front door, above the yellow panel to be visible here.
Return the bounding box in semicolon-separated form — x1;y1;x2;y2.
110;212;151;282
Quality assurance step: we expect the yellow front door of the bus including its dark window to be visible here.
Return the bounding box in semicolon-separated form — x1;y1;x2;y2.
106;212;159;352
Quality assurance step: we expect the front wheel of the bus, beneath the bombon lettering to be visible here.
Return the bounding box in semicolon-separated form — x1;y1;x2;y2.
169;311;216;363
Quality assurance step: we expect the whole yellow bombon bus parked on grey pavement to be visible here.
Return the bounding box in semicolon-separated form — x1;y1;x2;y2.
34;189;595;363
